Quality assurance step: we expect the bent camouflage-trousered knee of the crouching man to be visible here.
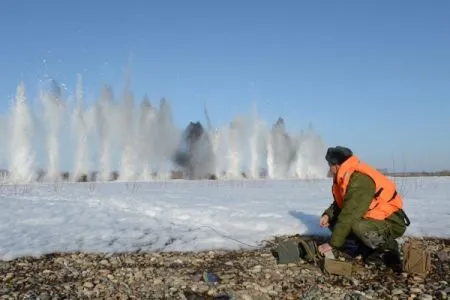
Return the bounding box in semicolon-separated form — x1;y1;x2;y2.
352;219;389;249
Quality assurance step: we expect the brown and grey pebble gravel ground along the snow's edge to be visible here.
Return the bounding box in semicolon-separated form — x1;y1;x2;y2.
0;238;450;300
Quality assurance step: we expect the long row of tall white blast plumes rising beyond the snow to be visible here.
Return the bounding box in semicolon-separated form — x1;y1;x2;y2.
0;76;327;182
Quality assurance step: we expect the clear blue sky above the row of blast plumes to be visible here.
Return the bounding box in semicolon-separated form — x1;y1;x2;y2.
0;0;450;170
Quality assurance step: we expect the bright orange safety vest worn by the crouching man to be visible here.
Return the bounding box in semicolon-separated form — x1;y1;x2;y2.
332;155;403;220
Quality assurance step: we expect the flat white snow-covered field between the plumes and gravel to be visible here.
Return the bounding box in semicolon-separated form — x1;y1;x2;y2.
0;177;450;260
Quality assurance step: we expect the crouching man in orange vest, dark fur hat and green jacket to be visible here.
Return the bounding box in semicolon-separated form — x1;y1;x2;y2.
319;146;409;271
